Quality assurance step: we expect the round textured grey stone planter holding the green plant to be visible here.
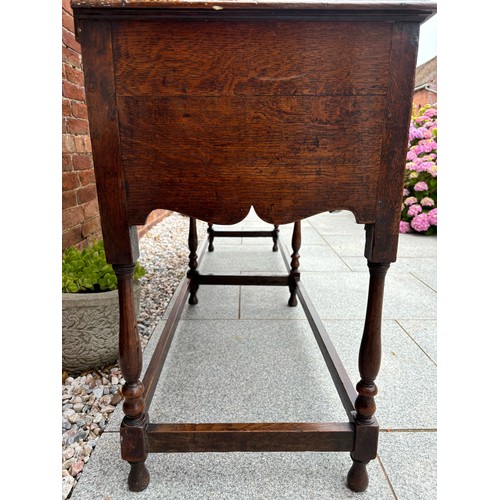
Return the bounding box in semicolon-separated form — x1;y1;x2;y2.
62;281;141;373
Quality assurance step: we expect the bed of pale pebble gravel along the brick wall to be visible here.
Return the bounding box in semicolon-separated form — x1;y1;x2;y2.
62;213;207;500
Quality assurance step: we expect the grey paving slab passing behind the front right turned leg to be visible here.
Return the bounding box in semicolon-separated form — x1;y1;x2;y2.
324;321;437;429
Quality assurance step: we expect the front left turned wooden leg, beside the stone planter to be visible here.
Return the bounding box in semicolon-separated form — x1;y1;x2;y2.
113;264;149;491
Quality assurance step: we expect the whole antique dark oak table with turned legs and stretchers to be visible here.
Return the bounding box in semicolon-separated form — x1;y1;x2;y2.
72;0;436;491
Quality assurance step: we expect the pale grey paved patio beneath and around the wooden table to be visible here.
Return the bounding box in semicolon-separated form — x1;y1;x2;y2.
71;211;437;500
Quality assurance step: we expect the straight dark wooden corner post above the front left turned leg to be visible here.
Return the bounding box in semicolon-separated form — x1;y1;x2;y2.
80;21;138;264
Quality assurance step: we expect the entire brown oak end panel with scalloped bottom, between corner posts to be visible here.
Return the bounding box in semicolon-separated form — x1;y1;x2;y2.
113;20;392;224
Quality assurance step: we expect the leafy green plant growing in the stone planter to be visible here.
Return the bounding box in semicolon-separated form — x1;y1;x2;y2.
62;240;146;293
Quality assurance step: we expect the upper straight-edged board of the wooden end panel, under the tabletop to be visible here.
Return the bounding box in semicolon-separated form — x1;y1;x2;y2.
113;19;391;96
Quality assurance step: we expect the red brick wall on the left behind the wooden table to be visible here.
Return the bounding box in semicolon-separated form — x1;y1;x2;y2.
62;0;170;250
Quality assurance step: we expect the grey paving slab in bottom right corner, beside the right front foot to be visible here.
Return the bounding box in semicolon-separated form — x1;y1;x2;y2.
378;432;438;500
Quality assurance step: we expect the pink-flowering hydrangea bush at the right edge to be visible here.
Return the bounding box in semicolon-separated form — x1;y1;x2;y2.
399;105;437;235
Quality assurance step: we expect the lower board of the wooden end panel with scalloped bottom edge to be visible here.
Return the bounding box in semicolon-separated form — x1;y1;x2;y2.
118;96;384;224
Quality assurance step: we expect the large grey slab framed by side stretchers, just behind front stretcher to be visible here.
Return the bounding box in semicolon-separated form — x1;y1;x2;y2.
145;320;347;423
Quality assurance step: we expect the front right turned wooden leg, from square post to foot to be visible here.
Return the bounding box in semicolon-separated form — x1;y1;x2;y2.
347;262;389;491
